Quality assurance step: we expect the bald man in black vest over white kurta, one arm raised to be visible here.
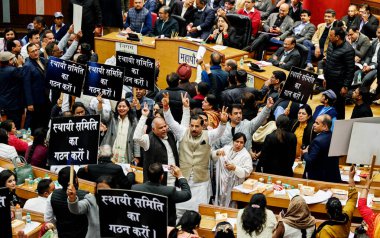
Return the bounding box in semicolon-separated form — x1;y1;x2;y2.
133;103;179;186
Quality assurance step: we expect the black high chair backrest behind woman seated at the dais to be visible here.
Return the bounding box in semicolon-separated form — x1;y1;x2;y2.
226;14;252;49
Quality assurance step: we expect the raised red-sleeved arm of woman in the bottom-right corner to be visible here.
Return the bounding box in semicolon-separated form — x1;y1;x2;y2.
358;176;380;238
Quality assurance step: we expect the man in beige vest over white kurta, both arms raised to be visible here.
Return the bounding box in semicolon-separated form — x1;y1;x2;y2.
162;94;228;217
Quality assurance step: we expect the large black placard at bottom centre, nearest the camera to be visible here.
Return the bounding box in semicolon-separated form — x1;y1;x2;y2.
97;189;168;238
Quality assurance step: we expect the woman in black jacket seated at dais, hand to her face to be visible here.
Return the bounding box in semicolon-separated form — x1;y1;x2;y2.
208;16;239;48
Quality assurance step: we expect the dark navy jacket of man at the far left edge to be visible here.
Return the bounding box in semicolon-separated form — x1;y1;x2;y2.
0;66;24;110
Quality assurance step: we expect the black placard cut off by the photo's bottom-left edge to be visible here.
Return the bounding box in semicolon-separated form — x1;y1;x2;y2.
0;188;12;238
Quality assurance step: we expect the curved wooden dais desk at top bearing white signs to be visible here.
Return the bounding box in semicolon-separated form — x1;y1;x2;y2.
95;32;248;88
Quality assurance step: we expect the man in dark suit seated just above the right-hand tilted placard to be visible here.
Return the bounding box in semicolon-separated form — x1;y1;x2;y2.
268;37;301;70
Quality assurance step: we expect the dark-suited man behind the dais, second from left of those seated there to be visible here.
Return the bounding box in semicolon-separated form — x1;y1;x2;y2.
154;6;179;38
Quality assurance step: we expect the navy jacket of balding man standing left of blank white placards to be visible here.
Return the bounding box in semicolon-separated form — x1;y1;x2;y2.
303;131;341;183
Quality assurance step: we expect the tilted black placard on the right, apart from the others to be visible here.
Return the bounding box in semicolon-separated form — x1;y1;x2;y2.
280;67;318;104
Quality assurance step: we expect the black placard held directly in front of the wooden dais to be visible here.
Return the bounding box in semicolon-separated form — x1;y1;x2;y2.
116;51;156;90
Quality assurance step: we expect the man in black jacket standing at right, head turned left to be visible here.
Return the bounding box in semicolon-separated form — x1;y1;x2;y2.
323;27;355;119
